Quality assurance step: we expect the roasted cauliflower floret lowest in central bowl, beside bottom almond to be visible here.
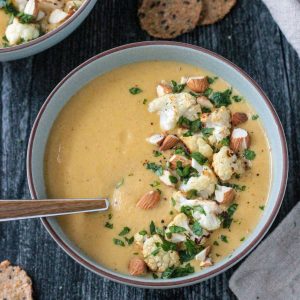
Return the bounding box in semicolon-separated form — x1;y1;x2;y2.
143;234;180;272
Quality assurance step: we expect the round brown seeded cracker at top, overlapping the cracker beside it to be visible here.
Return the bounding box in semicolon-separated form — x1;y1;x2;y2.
138;0;202;39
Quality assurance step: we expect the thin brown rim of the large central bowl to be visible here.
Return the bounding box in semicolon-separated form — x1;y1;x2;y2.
27;41;288;288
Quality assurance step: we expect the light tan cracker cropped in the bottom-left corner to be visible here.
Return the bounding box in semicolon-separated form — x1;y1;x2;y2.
0;260;32;300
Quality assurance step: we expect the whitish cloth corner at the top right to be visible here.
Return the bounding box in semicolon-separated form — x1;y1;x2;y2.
263;0;300;57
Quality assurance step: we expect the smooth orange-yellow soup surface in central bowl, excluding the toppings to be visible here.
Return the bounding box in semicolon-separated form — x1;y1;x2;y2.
45;61;271;273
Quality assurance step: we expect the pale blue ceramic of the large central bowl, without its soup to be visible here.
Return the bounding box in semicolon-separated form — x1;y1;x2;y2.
27;42;288;288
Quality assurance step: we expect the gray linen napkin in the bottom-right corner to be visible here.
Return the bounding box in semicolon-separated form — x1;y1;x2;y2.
229;202;300;300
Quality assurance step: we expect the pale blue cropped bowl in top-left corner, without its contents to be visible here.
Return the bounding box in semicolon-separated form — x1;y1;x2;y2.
0;0;97;61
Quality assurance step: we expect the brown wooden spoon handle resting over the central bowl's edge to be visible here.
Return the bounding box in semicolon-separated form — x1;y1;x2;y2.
0;199;109;221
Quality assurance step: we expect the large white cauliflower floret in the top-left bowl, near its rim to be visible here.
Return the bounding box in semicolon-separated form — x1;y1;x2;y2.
5;18;40;46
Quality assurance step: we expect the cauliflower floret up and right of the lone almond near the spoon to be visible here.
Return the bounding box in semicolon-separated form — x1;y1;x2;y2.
179;166;217;198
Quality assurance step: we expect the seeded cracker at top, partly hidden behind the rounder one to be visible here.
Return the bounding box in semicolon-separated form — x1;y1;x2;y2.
199;0;236;25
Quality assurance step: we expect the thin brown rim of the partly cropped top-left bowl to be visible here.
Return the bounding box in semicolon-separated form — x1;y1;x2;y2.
0;0;93;55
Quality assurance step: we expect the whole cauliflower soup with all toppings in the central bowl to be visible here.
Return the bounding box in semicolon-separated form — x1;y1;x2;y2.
45;61;271;278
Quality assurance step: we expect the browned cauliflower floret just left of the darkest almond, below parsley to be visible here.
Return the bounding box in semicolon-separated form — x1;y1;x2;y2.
201;106;231;145
